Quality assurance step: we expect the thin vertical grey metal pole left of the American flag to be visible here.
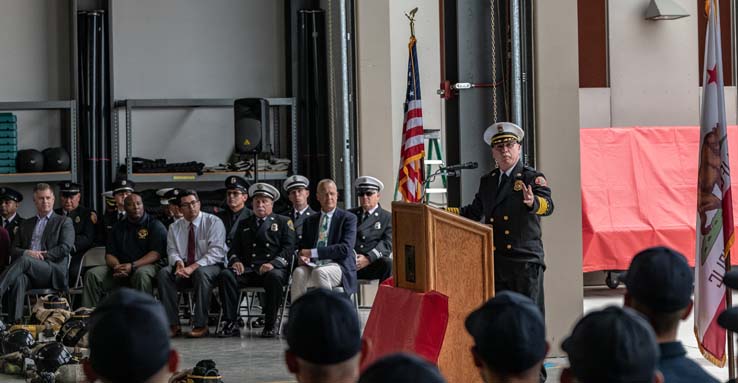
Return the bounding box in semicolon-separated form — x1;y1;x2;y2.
339;0;353;209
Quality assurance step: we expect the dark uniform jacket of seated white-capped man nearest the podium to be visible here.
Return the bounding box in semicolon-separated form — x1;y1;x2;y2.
349;206;392;262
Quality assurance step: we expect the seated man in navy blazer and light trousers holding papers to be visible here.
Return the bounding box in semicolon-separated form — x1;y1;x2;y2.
292;179;356;302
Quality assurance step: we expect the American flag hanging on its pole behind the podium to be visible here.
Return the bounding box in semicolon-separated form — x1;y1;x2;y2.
398;36;425;202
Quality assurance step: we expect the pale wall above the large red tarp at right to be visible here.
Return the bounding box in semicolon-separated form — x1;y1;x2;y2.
579;0;736;128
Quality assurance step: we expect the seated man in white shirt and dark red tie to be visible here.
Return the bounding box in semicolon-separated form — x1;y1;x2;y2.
158;190;228;338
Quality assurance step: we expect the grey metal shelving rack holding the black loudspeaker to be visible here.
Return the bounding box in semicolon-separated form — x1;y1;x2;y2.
111;98;297;182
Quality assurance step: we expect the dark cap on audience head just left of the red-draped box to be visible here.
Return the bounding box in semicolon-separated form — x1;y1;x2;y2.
286;289;361;365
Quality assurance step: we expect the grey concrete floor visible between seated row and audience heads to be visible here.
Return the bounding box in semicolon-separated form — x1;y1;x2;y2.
0;287;738;383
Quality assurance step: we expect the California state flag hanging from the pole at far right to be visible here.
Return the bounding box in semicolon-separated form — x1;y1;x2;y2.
694;0;734;367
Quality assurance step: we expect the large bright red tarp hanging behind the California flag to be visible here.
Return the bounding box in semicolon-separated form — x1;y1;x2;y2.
580;126;738;272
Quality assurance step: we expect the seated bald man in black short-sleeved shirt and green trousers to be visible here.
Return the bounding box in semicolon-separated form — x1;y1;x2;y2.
82;193;167;307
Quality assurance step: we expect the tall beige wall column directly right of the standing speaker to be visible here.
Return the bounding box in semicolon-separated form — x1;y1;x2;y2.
534;0;584;355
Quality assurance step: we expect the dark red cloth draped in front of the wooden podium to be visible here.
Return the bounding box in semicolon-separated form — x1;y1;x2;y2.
361;285;448;371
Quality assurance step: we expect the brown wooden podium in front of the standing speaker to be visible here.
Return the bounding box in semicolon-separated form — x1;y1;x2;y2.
392;202;494;383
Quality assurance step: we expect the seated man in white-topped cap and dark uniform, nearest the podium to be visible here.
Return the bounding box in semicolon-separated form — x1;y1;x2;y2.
349;176;392;281
